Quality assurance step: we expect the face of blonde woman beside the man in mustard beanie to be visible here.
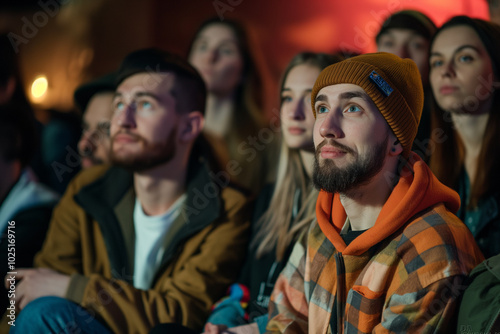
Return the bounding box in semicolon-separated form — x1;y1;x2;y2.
281;64;321;151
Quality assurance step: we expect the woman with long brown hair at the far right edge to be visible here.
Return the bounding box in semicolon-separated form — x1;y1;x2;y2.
430;16;500;258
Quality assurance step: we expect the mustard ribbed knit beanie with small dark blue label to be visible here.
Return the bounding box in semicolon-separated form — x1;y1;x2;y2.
311;52;424;158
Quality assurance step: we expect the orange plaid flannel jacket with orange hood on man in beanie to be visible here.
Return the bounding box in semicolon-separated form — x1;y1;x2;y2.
267;154;483;334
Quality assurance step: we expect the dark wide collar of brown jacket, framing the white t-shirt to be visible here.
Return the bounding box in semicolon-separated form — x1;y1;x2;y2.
75;157;222;282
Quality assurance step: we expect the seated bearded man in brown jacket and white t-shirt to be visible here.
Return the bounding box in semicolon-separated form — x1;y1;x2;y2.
11;49;254;333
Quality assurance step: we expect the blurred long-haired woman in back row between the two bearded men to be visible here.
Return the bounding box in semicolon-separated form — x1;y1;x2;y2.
188;19;277;194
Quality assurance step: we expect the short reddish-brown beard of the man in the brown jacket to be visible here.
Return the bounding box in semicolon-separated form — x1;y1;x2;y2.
111;129;177;172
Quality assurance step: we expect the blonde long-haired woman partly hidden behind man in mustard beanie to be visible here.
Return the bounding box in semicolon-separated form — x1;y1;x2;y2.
205;53;342;333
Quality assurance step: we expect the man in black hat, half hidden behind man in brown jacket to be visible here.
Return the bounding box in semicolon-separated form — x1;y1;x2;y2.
74;73;115;168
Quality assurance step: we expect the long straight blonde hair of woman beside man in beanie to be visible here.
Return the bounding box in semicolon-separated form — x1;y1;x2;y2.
251;52;342;261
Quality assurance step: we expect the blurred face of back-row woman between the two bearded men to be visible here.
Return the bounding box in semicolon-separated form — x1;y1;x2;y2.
189;23;244;96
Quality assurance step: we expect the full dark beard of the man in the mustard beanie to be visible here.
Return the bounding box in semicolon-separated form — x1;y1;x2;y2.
313;136;389;194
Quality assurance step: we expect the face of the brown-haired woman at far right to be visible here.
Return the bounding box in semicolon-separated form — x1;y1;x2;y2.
429;25;494;114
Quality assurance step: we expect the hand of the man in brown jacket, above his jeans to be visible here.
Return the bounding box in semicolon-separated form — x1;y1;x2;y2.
5;268;70;310
